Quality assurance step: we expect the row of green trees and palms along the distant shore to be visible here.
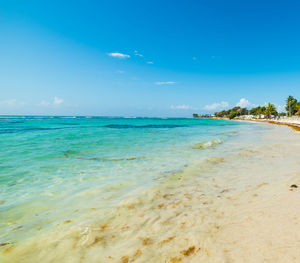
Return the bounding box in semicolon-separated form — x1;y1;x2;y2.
214;96;300;119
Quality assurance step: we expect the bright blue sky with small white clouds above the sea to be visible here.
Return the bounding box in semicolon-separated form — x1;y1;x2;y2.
0;0;300;116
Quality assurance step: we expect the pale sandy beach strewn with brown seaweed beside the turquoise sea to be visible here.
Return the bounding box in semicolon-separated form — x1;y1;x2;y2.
1;124;300;263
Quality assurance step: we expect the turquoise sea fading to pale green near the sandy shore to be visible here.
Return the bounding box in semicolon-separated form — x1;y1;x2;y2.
0;116;257;245
